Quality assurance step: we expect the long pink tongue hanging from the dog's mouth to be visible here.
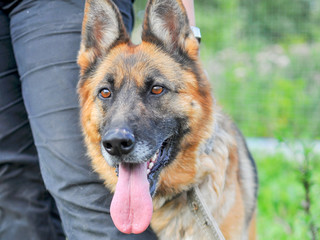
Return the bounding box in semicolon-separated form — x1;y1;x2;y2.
110;163;153;234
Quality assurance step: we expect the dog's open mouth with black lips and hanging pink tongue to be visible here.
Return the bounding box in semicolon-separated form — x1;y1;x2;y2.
110;139;173;234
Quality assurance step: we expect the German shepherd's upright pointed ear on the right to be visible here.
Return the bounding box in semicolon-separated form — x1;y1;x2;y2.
142;0;199;59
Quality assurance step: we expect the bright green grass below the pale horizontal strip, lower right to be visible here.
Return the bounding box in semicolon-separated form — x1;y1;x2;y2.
254;153;320;240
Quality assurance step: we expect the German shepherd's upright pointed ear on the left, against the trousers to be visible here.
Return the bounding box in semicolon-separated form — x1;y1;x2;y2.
78;0;130;74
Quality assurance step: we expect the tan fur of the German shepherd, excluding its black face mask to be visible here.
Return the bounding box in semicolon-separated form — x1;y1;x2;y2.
78;0;256;240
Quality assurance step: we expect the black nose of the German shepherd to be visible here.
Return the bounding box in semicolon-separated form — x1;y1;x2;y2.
102;128;135;156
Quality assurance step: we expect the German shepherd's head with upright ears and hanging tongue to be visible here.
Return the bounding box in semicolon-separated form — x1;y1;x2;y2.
78;0;213;233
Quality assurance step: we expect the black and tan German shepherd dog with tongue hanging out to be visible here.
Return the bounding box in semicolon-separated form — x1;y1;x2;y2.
78;0;257;240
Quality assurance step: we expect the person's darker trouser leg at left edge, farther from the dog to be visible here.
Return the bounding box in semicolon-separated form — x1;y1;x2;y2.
0;9;65;240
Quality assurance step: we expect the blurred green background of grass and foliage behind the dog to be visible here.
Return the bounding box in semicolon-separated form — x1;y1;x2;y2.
133;0;320;240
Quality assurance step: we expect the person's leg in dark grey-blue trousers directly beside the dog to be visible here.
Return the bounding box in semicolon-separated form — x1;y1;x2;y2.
11;0;156;240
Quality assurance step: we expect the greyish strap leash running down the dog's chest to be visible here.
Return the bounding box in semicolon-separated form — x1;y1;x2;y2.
187;186;225;240
